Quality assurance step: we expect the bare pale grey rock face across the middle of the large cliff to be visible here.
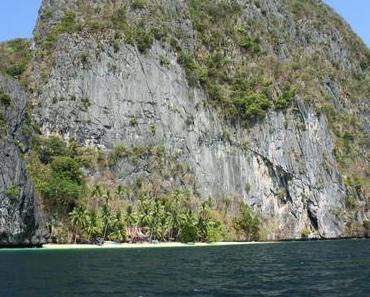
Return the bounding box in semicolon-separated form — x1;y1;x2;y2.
37;38;345;238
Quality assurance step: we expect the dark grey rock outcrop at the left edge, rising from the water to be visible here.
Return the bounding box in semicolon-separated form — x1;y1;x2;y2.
0;76;47;246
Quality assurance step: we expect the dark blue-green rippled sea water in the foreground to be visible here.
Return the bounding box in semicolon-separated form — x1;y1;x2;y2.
0;240;370;297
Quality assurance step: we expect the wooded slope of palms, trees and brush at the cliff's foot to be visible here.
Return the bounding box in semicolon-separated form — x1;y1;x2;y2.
28;136;260;242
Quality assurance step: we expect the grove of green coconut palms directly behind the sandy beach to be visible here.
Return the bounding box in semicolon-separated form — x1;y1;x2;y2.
65;185;259;242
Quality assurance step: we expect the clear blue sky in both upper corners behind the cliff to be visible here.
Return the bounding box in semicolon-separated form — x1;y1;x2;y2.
0;0;370;47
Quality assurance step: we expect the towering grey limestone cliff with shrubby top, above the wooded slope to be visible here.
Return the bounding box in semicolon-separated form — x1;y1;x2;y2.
0;0;370;243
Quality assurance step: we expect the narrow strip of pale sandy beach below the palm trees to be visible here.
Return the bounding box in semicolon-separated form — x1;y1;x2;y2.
42;241;267;249
